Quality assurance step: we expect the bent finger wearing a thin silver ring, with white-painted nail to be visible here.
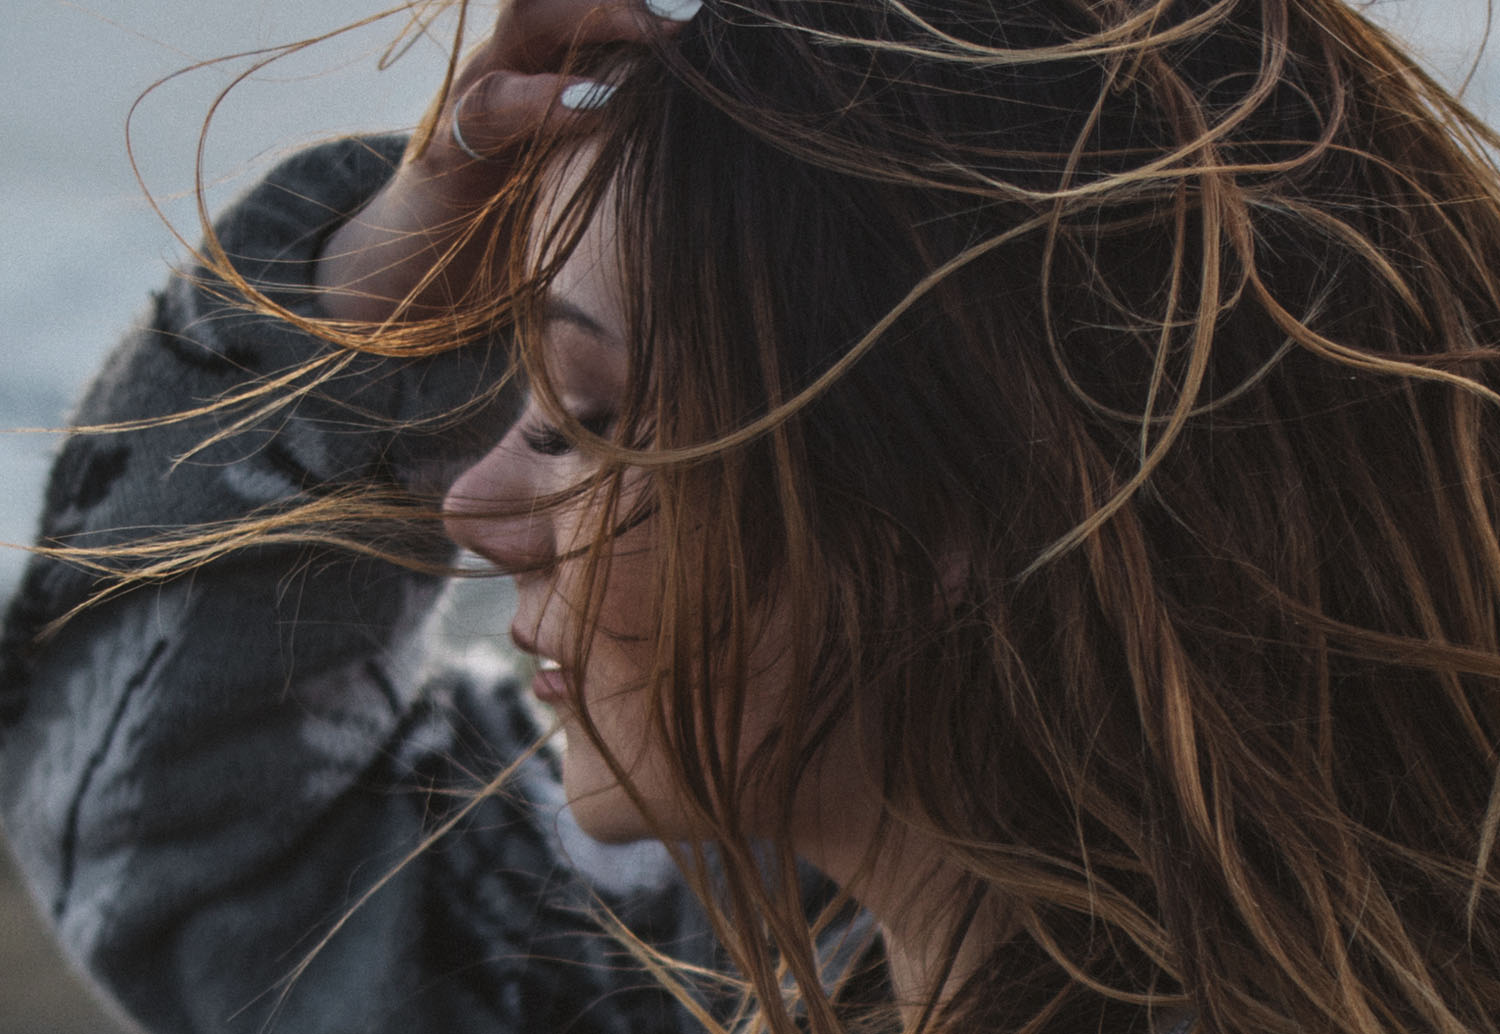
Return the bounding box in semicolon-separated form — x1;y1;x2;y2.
450;72;615;161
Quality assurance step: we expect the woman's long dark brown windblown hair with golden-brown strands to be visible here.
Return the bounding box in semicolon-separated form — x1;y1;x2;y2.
486;0;1500;1034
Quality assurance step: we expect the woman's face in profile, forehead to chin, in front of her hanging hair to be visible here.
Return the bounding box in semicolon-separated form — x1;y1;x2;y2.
444;161;677;840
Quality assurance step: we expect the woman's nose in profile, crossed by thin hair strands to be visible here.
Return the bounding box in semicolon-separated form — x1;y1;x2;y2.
443;431;557;575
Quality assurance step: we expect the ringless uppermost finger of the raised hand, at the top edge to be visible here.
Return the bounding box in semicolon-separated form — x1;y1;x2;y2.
491;0;702;72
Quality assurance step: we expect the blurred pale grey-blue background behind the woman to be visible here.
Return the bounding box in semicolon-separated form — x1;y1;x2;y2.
0;0;1500;1034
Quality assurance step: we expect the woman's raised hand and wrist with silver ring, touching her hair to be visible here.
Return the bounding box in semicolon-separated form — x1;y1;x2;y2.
317;0;702;323
